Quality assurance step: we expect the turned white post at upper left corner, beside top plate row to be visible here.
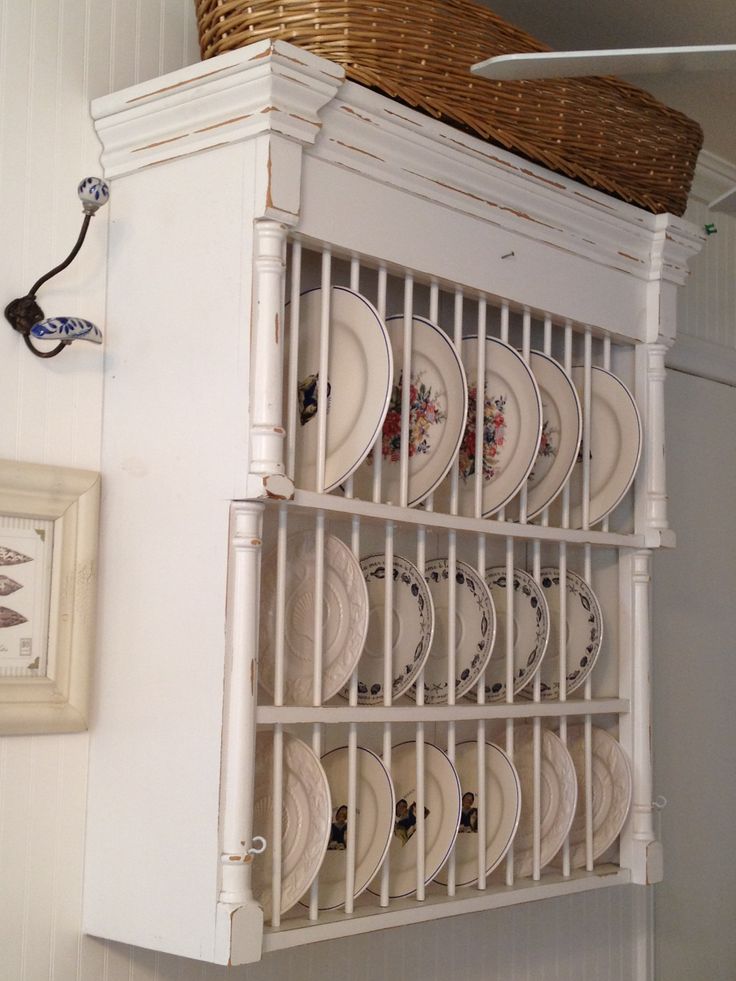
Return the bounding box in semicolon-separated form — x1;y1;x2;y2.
248;218;294;500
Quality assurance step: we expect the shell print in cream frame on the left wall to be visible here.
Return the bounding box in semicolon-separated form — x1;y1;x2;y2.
0;460;100;735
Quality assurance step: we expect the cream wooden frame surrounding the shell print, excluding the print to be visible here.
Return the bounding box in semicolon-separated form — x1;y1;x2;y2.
0;460;100;735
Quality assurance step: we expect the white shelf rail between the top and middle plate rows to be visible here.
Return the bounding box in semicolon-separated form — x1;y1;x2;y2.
269;490;647;548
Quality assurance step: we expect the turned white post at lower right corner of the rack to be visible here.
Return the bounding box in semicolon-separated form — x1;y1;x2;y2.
619;549;663;885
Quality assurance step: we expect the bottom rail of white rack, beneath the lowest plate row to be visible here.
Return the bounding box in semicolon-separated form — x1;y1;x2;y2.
263;865;631;953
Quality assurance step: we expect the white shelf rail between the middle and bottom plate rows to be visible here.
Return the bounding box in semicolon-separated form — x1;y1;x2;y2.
256;698;629;725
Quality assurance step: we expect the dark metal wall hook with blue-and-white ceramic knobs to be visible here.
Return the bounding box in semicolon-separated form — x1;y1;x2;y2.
5;177;110;358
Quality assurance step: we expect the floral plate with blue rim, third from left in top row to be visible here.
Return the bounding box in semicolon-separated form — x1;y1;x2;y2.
435;336;542;517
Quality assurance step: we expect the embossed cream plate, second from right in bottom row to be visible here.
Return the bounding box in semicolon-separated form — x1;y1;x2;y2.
504;725;578;877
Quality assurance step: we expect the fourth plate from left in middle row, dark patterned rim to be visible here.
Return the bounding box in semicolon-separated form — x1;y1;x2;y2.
474;566;549;702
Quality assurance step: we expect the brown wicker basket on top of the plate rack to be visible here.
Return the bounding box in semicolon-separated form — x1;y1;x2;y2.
195;0;702;215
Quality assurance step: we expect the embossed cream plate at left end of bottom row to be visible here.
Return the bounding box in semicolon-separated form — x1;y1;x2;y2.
253;732;332;918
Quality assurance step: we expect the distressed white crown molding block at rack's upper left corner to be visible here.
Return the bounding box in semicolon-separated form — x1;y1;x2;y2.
92;41;344;178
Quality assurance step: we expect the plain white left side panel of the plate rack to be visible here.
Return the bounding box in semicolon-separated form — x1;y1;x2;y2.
84;144;253;959
